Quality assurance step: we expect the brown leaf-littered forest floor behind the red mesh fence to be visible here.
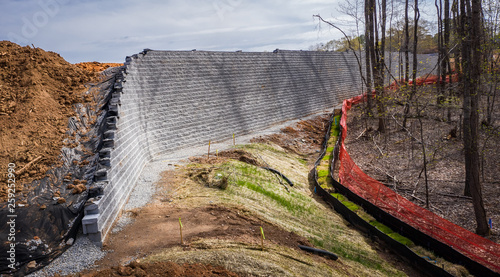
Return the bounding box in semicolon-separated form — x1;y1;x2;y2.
345;86;500;243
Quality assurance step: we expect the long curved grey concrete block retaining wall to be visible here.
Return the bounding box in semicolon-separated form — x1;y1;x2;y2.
83;50;438;242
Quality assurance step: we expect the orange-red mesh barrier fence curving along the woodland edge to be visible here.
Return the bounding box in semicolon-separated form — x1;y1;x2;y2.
339;85;500;273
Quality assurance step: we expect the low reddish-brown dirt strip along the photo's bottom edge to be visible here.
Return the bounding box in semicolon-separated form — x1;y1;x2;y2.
83;262;239;277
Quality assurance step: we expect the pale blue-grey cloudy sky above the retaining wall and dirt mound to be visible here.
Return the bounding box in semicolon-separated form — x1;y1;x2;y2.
0;0;360;63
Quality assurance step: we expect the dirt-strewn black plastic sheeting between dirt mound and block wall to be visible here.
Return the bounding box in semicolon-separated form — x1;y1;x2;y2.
0;68;122;276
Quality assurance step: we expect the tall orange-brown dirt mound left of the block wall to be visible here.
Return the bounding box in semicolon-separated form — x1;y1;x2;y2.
0;41;98;200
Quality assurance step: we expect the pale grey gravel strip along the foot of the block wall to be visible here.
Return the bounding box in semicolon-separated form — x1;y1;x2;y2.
28;109;333;277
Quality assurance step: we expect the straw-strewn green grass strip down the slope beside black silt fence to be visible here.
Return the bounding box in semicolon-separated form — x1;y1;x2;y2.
183;144;404;276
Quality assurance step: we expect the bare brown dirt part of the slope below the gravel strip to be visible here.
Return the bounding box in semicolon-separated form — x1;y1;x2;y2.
72;115;421;276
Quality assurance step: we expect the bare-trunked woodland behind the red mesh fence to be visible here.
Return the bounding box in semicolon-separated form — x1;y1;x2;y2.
310;0;500;237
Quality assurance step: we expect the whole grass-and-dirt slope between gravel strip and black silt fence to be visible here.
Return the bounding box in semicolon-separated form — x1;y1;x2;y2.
72;115;419;276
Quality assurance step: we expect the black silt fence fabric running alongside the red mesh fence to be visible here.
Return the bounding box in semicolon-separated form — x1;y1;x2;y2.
311;110;460;277
